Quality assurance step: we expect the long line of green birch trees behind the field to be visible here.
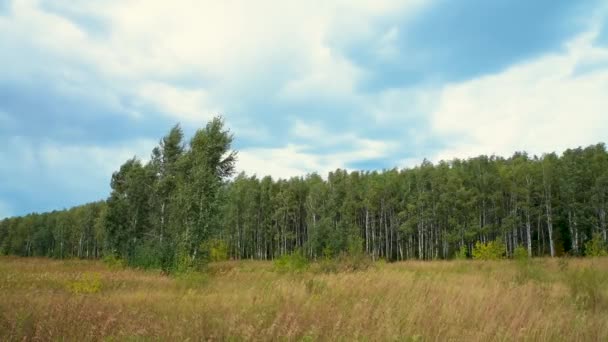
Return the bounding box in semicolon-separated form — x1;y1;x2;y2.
0;118;608;269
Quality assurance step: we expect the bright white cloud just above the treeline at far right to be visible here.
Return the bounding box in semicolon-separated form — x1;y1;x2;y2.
432;32;608;160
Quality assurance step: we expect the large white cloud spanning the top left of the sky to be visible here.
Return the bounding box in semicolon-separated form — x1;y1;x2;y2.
0;0;427;125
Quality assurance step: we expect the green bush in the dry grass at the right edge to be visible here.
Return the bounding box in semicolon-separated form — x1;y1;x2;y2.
566;267;608;311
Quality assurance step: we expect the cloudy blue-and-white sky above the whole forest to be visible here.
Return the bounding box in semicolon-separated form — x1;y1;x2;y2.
0;0;608;218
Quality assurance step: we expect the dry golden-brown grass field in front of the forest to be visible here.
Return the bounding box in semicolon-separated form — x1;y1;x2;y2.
0;257;608;341
